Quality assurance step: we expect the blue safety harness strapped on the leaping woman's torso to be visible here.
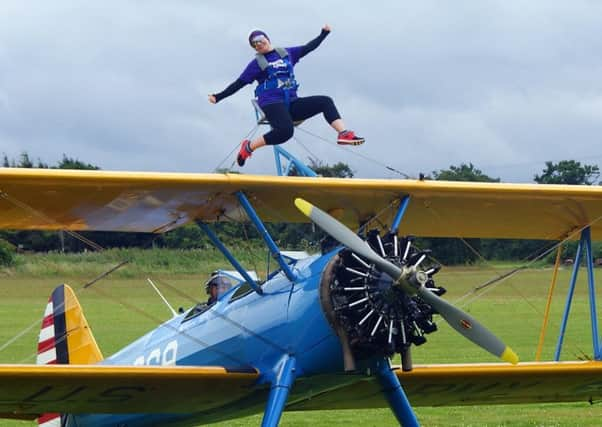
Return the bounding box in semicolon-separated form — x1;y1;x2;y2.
255;47;299;107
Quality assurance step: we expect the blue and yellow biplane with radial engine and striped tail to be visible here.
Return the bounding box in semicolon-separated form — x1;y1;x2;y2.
0;162;602;427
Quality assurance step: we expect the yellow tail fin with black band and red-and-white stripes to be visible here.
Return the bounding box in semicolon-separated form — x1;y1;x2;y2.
37;285;103;427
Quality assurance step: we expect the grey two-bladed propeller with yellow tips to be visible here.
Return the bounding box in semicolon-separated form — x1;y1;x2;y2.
295;198;518;364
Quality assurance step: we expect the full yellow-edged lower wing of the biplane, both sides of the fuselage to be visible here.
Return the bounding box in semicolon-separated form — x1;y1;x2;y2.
0;362;602;418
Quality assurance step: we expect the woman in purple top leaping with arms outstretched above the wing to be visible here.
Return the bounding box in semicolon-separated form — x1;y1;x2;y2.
209;25;364;166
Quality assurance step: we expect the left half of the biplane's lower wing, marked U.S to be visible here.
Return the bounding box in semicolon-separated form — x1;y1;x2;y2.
0;365;259;418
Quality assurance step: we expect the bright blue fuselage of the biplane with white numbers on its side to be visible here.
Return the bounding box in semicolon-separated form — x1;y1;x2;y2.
68;252;343;427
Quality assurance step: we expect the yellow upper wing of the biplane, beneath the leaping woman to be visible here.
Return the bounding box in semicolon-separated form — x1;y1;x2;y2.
0;168;602;240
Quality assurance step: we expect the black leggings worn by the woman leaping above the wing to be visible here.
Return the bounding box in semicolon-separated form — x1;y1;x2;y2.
262;95;341;145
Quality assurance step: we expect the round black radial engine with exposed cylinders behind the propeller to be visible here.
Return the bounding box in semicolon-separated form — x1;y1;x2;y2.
321;230;445;365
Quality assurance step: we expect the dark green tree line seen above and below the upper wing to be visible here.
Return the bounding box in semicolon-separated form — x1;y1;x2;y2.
0;153;602;265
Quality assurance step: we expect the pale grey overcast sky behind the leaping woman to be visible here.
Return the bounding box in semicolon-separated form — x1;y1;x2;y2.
0;0;602;182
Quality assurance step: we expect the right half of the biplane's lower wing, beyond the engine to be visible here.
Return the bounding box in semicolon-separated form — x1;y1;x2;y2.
287;362;602;410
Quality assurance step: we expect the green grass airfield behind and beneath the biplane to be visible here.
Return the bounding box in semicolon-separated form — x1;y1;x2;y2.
0;253;602;426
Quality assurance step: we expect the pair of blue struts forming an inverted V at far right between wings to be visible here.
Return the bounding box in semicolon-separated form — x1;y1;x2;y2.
554;227;602;361
